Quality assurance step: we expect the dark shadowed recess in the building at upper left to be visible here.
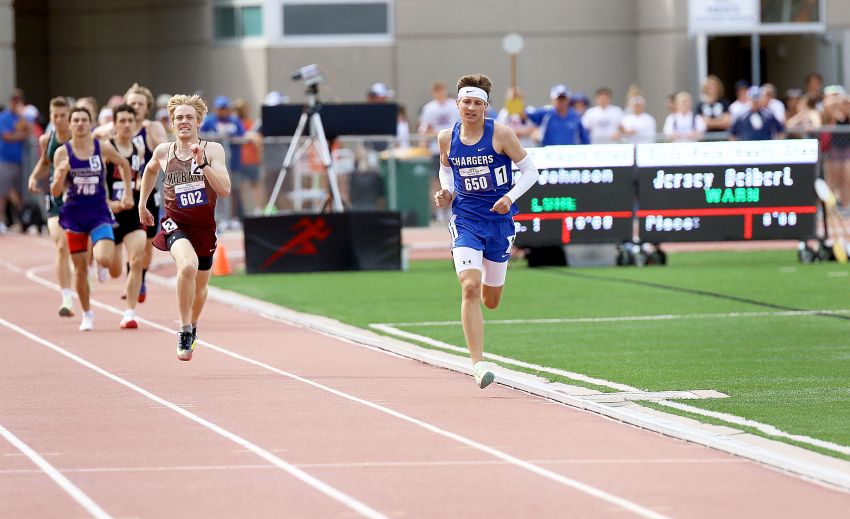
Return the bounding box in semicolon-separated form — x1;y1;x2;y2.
16;0;212;113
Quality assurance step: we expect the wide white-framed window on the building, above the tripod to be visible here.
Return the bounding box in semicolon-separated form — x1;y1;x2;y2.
283;0;392;38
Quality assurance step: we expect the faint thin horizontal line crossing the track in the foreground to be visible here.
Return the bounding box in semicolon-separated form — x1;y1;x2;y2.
0;458;749;476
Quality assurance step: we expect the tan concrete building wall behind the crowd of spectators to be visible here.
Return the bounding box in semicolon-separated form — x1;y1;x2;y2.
9;0;850;124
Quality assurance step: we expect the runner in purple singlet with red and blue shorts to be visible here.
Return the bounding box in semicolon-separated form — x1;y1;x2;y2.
50;108;133;331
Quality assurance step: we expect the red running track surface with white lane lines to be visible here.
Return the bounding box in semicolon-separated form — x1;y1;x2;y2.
0;236;850;517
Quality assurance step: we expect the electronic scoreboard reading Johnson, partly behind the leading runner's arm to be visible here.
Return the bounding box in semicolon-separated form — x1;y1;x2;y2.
506;144;634;247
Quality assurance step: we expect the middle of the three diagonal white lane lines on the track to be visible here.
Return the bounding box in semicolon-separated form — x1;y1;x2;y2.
0;314;385;519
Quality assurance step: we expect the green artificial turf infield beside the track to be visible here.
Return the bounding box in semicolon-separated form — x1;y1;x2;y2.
213;251;850;459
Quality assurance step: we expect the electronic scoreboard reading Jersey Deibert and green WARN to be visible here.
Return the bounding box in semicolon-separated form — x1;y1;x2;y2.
636;139;818;243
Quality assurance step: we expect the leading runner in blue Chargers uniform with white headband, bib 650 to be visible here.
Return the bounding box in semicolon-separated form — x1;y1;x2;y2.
434;74;538;389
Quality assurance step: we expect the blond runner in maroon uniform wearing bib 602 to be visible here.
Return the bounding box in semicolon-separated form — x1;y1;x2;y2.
139;95;230;360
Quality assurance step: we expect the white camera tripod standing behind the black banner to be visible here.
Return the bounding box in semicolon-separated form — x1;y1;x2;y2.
263;83;343;216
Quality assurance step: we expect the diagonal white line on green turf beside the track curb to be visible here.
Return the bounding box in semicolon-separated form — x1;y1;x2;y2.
372;324;850;455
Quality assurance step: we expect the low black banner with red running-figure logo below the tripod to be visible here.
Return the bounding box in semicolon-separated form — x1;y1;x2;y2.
244;211;401;274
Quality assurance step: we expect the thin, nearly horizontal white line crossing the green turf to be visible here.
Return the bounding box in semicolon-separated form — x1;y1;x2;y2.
369;308;850;327
